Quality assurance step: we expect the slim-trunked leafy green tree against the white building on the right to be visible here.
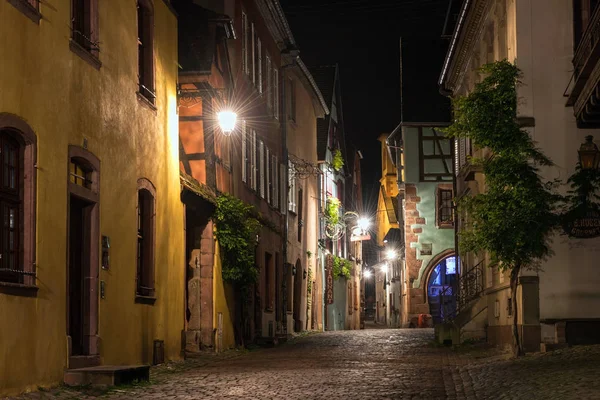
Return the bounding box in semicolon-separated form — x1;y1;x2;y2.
447;60;561;356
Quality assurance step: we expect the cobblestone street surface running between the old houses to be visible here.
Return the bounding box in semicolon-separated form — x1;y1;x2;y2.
7;329;600;400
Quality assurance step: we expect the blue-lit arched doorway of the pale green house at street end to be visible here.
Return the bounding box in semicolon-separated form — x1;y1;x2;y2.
427;254;458;324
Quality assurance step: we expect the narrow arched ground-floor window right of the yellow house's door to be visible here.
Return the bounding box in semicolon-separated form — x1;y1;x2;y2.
136;179;155;297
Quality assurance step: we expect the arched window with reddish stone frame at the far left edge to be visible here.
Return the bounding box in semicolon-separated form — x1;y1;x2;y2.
0;113;36;288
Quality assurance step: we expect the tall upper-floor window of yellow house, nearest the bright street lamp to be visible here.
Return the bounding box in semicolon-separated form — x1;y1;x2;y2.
137;0;156;104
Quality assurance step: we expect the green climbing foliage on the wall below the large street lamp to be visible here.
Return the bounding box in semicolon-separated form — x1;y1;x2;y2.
214;194;260;287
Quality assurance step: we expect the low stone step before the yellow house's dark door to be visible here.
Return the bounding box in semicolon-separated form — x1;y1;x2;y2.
63;365;150;386
